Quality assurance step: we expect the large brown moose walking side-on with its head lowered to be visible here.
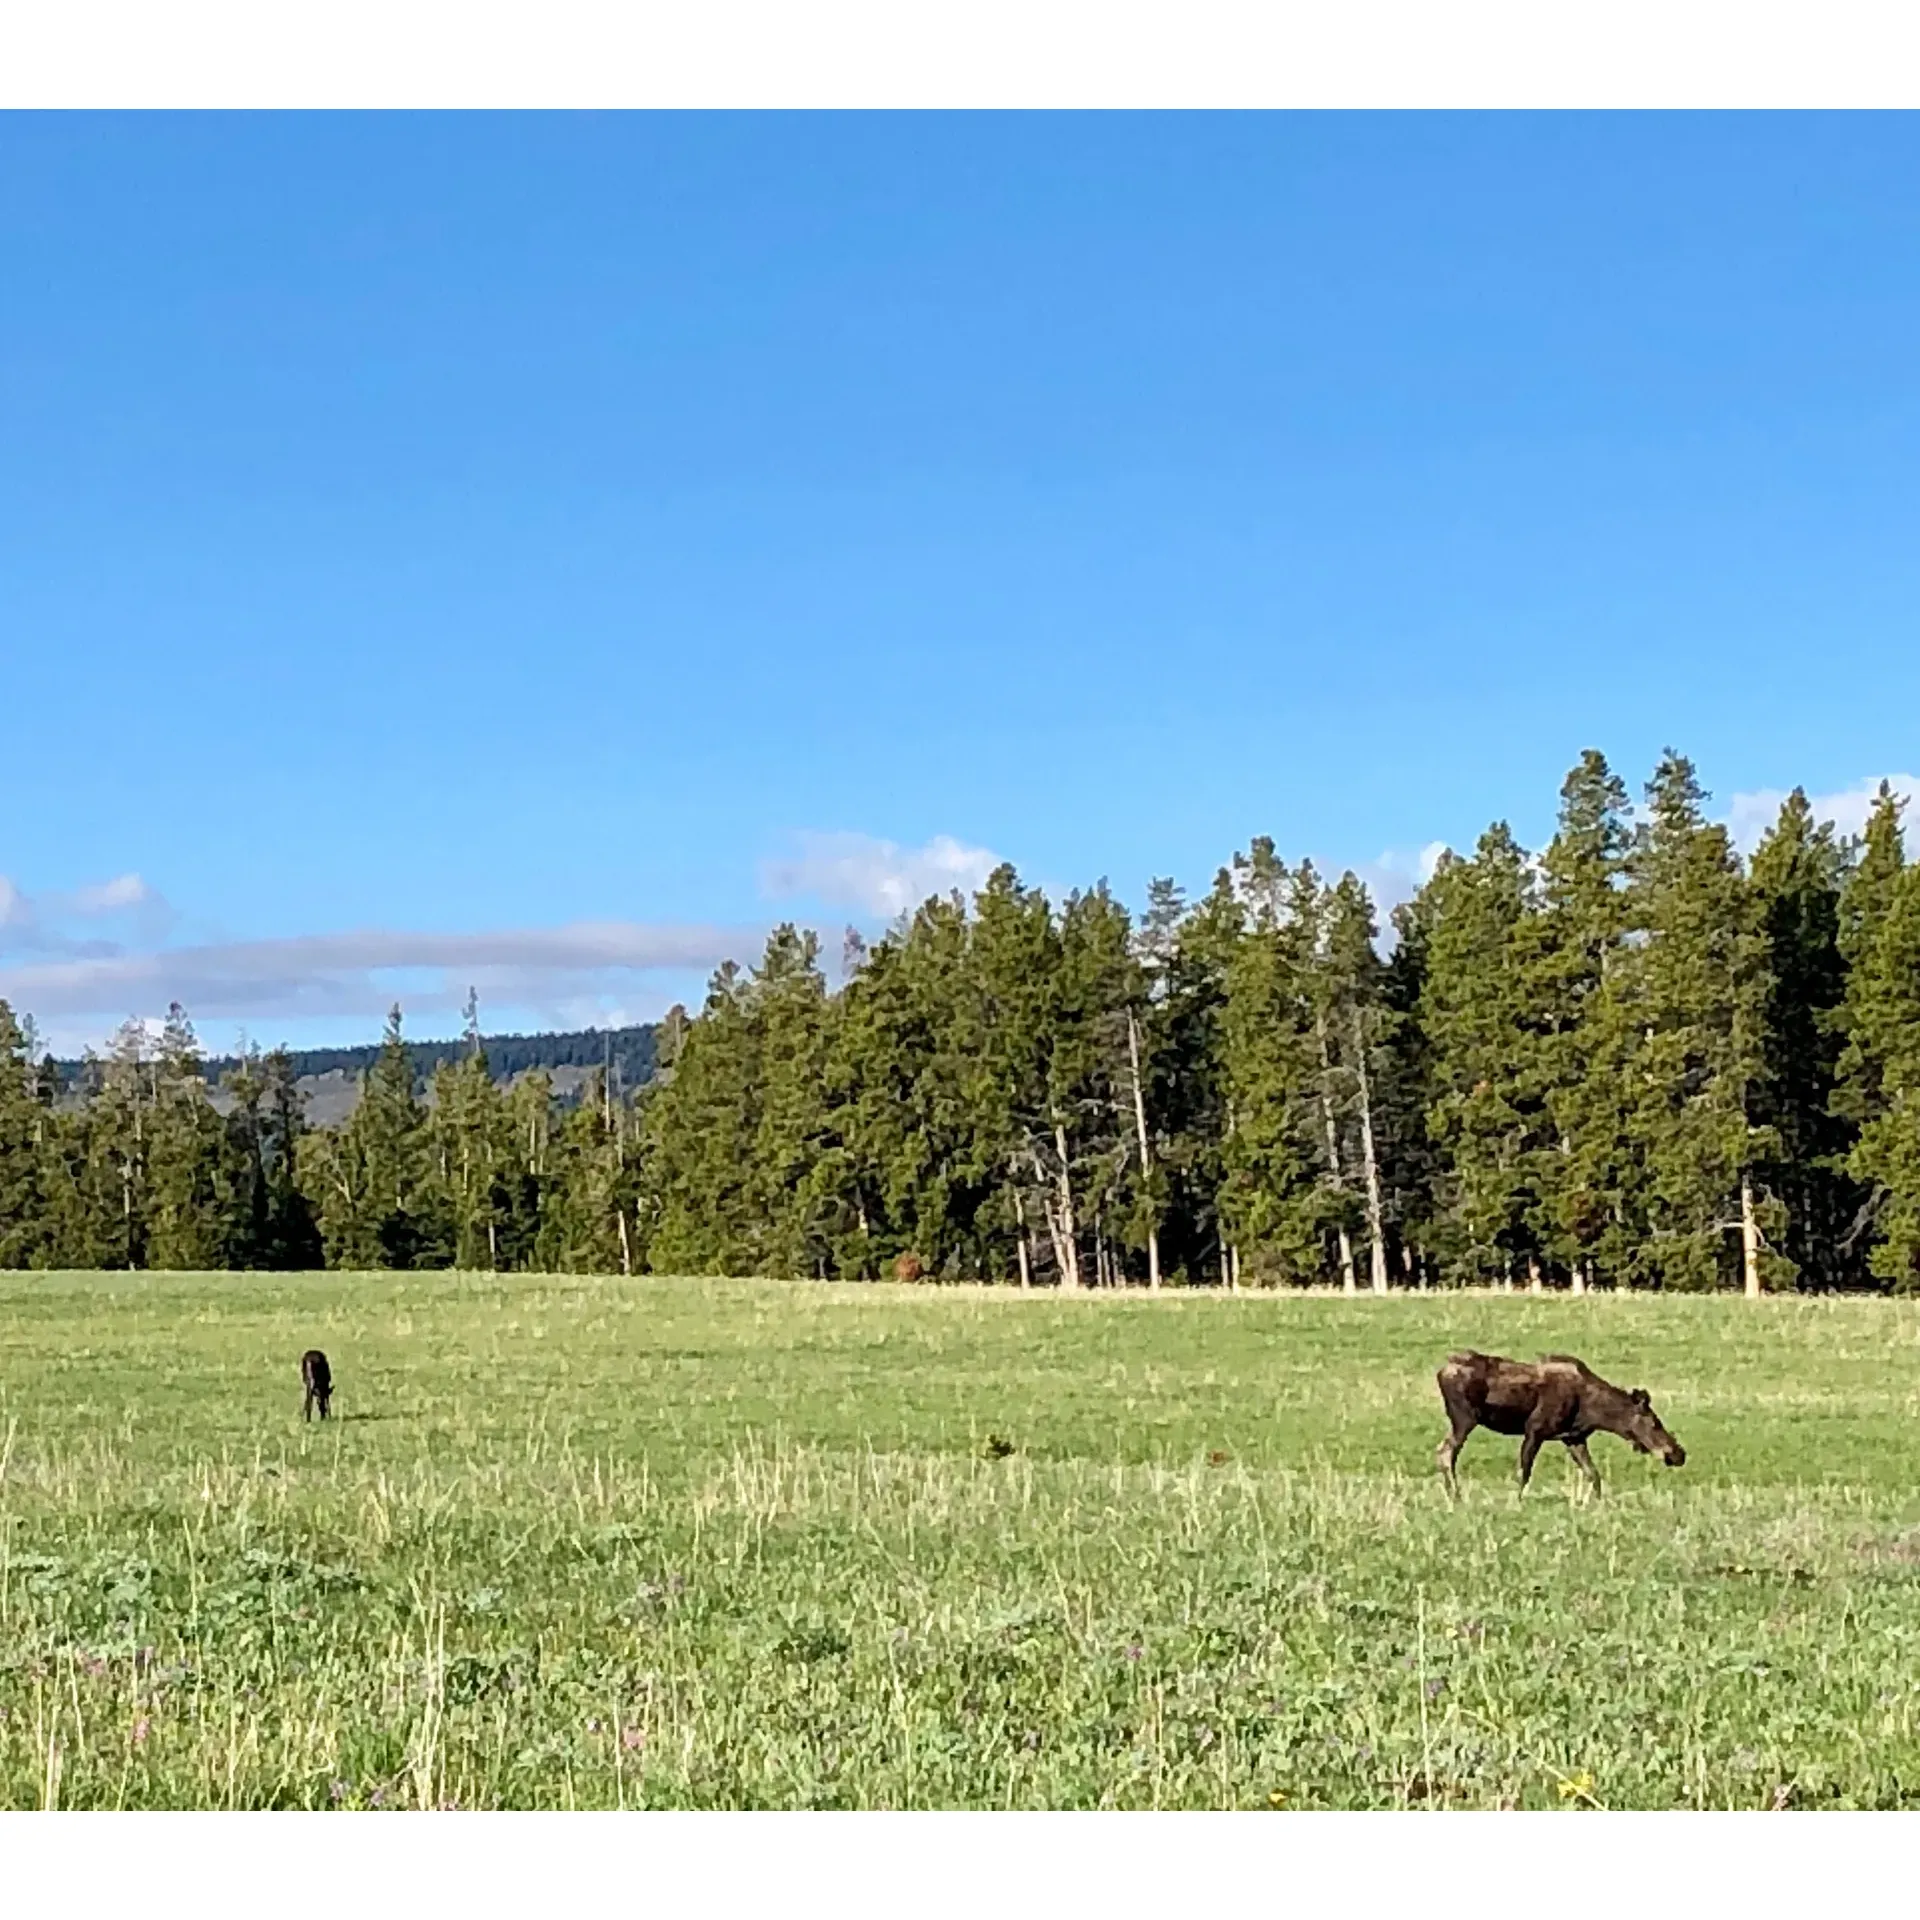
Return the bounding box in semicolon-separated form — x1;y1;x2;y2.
1438;1354;1686;1498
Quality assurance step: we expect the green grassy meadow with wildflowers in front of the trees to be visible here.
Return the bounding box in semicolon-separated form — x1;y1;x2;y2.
0;1275;1920;1809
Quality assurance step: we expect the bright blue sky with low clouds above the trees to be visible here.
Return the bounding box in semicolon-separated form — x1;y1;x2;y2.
0;113;1920;1044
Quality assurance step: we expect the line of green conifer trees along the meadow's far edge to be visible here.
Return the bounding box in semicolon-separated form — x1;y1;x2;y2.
0;753;1920;1294
